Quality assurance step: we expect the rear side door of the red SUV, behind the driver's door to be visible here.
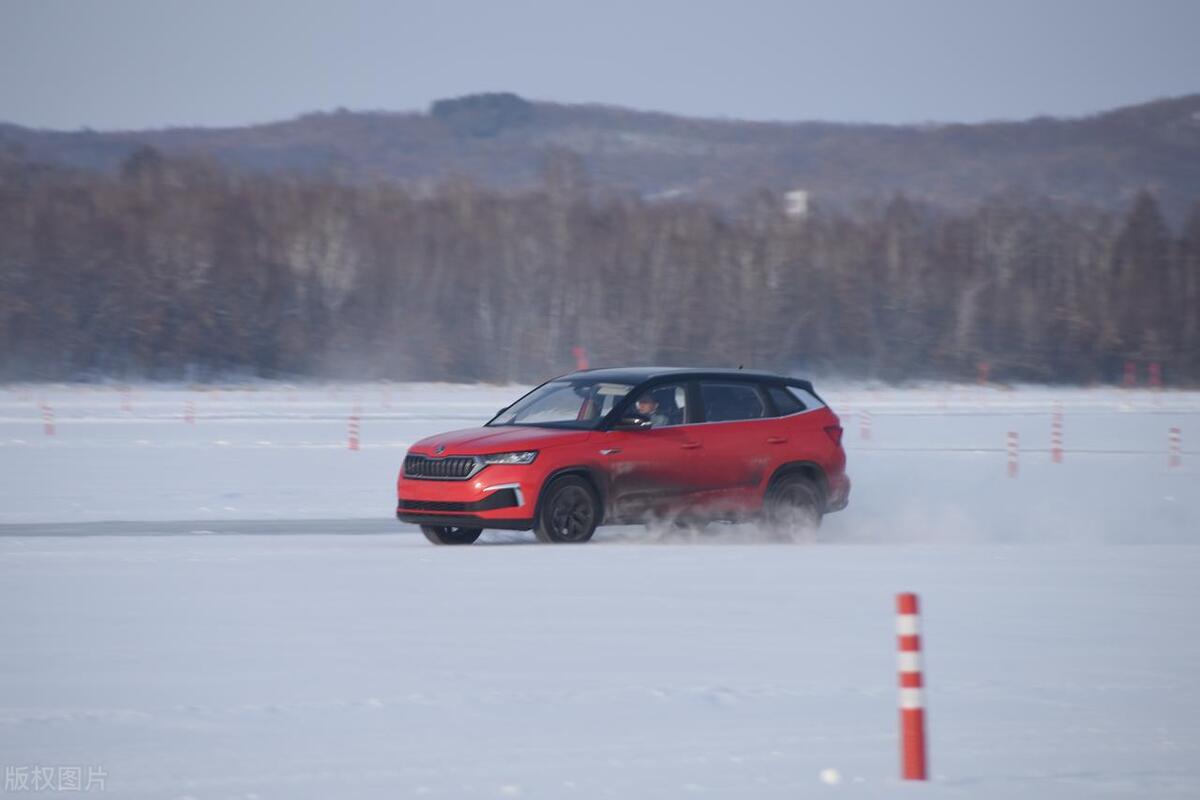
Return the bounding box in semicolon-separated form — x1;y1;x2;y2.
700;379;784;513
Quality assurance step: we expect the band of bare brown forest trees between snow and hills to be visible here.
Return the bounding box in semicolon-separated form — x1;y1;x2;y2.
0;150;1200;385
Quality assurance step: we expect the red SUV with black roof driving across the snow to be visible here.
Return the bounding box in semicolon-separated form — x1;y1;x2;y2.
396;367;850;545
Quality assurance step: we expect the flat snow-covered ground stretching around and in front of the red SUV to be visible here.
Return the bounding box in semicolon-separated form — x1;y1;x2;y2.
0;384;1200;799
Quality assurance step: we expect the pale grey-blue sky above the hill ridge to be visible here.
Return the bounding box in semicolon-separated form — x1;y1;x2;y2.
0;0;1200;130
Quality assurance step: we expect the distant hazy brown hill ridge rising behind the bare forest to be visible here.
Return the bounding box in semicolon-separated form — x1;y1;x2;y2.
0;94;1200;219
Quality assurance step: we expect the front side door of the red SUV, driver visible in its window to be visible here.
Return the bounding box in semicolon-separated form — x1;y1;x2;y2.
596;381;704;522
